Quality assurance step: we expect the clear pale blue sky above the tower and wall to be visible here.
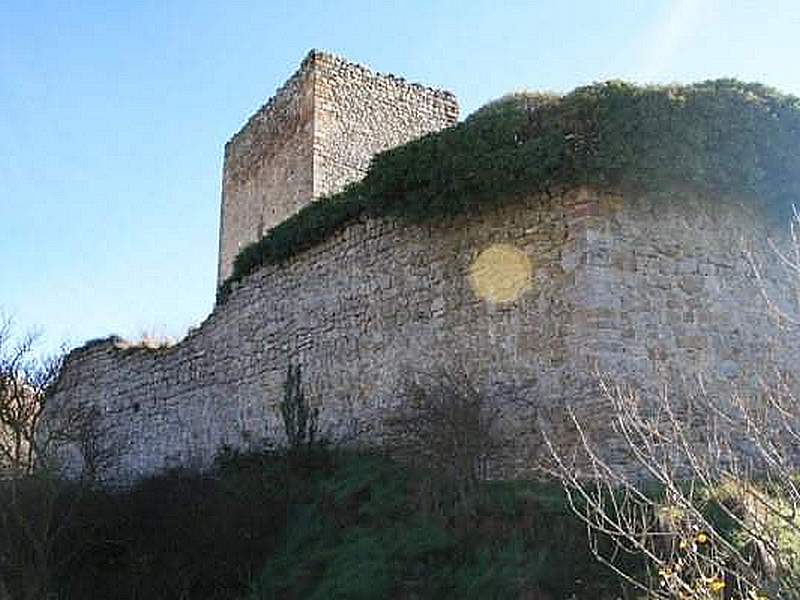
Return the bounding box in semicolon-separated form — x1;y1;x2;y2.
0;0;800;348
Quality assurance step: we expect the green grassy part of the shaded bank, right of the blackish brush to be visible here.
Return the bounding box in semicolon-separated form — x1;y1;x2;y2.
249;454;620;600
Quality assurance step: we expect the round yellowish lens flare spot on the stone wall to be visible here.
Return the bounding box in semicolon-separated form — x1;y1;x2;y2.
470;244;533;304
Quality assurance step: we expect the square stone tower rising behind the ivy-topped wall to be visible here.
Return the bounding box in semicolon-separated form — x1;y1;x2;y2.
217;50;458;285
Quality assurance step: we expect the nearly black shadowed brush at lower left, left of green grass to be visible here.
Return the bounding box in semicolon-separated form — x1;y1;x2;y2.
54;469;285;600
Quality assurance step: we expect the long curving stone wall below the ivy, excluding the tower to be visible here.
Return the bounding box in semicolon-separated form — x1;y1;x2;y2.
48;189;800;482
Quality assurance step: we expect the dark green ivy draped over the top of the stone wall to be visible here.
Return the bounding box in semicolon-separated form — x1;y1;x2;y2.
219;79;800;300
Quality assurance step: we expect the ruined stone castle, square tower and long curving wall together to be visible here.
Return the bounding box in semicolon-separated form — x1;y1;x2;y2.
52;51;797;481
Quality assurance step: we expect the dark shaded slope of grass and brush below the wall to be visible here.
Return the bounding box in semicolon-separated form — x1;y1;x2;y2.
36;453;632;600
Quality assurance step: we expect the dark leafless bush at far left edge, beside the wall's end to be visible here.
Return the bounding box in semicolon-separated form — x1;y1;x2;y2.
0;317;117;600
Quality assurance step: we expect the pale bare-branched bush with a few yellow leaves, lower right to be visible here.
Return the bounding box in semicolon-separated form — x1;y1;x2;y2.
541;209;800;600
